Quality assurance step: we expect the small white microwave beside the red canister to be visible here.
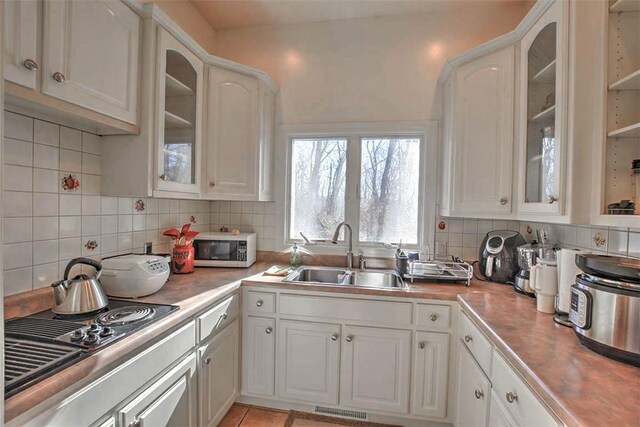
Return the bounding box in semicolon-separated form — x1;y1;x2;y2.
193;233;256;267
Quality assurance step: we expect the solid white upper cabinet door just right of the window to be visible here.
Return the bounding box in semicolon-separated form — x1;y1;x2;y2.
445;46;514;216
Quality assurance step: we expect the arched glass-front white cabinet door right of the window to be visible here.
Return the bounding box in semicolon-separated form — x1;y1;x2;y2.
518;0;567;215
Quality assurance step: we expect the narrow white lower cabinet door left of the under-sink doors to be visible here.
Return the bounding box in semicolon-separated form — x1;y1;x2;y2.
242;316;276;396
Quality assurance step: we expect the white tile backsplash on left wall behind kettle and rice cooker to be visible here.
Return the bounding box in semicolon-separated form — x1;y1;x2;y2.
2;112;210;296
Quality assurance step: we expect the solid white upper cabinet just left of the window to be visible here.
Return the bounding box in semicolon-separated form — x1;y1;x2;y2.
203;67;275;200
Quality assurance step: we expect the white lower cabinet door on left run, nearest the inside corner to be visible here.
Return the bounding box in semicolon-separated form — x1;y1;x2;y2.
198;320;239;426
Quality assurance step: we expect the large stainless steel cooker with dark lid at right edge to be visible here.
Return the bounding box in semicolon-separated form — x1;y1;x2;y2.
569;254;640;366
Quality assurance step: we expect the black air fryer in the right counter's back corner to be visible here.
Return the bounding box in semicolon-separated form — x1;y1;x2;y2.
478;230;527;283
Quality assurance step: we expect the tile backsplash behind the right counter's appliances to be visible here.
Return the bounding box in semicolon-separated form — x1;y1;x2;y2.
435;218;640;261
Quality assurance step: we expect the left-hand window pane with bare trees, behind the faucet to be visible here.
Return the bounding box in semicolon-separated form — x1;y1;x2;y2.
289;138;347;239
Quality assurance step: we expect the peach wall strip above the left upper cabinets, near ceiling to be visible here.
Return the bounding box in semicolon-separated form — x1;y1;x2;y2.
143;0;216;53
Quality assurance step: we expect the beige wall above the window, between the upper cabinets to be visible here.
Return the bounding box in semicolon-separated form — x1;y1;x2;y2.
214;2;525;124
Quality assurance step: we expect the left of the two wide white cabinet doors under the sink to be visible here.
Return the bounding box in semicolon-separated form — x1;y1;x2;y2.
277;320;340;405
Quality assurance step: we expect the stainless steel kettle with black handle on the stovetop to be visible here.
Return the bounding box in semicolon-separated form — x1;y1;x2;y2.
51;258;109;314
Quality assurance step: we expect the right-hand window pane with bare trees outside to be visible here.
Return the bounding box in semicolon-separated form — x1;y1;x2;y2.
360;138;420;244
